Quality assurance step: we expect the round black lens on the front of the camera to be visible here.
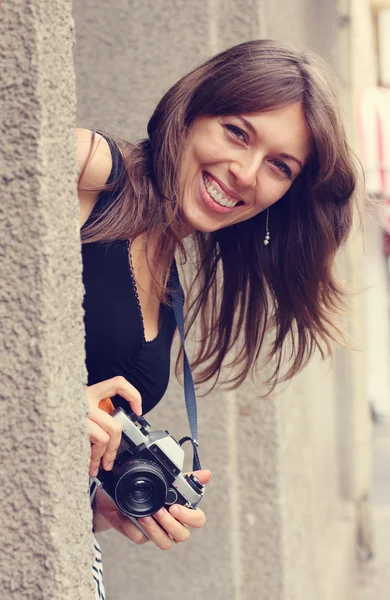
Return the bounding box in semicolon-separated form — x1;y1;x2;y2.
113;459;168;518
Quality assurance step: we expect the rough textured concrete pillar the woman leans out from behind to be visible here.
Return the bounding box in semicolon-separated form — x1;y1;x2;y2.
0;0;93;600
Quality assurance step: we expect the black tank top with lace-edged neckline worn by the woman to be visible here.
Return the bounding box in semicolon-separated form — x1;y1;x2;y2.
82;138;176;414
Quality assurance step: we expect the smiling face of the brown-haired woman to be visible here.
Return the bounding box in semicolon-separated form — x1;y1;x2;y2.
180;103;311;234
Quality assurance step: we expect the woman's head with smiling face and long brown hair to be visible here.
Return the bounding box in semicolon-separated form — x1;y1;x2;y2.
82;40;357;385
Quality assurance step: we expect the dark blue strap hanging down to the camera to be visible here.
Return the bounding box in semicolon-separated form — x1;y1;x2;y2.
171;261;202;471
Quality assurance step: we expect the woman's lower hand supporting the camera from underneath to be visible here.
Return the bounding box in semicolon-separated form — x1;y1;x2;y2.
94;470;211;550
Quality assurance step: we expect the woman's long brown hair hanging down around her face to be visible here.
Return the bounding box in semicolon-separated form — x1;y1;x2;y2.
83;40;357;387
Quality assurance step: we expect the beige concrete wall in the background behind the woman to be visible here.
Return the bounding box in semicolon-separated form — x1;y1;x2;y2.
74;0;365;600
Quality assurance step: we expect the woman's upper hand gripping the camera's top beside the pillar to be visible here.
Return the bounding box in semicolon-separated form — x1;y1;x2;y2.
86;376;142;477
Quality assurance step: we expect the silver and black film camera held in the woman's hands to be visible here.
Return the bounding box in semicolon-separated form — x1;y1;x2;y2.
94;408;204;529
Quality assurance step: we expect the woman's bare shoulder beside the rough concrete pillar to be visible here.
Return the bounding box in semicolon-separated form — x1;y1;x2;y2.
76;129;112;226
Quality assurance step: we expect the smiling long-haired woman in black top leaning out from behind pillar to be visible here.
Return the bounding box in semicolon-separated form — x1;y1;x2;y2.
78;40;356;596
